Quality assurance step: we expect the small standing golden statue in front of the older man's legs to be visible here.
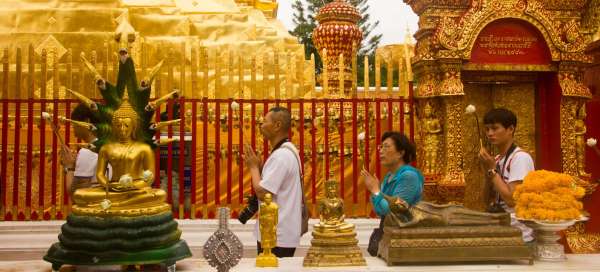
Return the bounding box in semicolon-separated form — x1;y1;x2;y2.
256;193;279;267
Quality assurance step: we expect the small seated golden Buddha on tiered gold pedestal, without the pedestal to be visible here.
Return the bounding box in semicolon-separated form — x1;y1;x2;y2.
314;179;354;233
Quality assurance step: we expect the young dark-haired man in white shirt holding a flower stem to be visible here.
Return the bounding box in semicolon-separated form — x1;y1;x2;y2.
479;108;535;243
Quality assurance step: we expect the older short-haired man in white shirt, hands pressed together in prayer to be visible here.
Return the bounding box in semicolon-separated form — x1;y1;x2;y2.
244;107;302;258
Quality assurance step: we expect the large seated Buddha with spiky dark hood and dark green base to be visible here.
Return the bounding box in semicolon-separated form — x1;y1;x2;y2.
44;45;191;271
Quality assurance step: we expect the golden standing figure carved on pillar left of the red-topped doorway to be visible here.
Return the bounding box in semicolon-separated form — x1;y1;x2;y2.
423;102;442;174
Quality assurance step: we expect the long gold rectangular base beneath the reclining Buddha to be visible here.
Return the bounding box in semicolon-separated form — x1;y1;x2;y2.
379;226;533;265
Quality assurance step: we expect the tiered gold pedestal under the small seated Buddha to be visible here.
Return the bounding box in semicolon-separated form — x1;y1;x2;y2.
303;226;367;267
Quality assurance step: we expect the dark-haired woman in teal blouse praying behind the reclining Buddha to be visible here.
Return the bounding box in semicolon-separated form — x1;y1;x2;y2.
361;131;424;217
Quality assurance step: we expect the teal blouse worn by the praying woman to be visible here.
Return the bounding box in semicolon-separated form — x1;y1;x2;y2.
371;164;425;216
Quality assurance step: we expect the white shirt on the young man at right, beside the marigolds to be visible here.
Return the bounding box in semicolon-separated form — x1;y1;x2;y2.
496;147;535;242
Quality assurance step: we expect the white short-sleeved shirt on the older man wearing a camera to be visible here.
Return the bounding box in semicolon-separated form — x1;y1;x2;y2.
254;142;302;248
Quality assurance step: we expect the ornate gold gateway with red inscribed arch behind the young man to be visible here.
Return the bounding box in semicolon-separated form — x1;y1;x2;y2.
404;0;600;251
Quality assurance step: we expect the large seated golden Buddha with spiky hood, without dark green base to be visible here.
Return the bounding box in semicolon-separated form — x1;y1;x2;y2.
72;49;173;216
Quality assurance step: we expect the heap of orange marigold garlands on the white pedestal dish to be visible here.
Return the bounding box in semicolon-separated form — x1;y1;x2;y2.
513;170;585;221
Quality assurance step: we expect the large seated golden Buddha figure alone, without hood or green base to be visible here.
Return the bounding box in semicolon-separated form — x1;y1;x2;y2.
73;95;169;216
